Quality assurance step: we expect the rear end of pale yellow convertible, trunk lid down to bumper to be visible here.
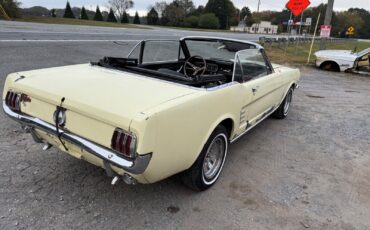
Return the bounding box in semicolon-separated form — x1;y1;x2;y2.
3;64;199;183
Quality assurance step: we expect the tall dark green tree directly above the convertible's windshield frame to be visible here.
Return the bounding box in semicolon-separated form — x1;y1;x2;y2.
205;0;236;29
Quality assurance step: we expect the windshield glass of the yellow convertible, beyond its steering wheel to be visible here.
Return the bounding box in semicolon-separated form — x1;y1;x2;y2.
185;40;256;61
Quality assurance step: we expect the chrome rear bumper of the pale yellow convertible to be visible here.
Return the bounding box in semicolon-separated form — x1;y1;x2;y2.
3;101;152;174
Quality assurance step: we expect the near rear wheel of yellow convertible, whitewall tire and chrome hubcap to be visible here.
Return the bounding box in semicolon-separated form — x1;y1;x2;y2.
182;126;229;191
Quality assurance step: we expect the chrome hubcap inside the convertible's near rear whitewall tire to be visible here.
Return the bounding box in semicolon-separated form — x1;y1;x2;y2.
203;135;226;181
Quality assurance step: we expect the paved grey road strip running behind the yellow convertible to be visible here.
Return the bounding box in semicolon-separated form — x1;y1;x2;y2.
0;21;272;41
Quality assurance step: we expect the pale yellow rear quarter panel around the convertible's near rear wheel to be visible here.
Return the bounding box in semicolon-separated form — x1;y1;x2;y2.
131;83;243;183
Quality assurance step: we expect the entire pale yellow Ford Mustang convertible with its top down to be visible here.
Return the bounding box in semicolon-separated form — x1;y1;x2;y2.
3;37;300;191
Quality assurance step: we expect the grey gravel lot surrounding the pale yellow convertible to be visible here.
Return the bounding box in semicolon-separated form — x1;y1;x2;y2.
0;20;370;229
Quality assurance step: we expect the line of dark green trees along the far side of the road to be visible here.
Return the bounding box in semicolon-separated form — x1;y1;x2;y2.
0;0;370;39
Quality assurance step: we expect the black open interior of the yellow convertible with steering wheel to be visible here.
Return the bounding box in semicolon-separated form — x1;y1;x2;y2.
92;37;268;88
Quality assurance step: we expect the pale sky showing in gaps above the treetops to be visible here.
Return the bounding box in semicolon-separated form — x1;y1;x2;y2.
19;0;370;16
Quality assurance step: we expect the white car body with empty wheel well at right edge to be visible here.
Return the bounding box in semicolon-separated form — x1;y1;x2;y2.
315;48;370;73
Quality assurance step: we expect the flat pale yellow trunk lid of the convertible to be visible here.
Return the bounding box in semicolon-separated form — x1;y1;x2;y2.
10;64;195;127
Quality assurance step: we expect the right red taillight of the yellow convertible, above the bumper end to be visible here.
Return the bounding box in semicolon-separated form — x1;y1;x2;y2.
111;129;136;158
